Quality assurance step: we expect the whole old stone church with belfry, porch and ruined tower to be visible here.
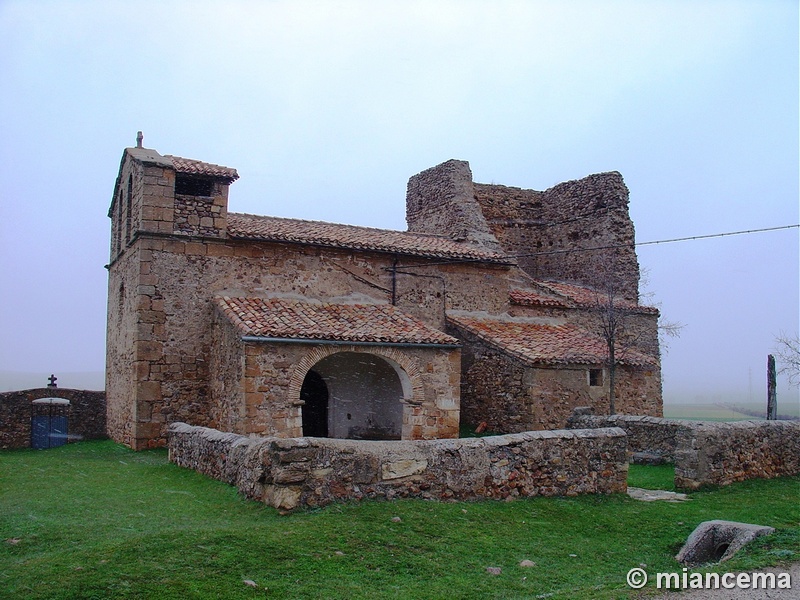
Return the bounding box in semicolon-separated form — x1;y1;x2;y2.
106;137;662;449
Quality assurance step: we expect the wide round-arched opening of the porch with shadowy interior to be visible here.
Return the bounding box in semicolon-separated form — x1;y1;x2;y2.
300;352;411;440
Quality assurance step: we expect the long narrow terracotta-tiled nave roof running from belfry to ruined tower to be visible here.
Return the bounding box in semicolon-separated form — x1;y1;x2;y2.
228;213;512;264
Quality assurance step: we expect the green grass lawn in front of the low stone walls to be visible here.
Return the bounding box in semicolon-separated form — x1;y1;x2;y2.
0;441;800;600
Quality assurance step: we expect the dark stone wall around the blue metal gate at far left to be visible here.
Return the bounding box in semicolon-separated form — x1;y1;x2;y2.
0;388;106;449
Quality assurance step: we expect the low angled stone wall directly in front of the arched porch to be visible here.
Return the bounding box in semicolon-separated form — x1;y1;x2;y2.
169;423;628;510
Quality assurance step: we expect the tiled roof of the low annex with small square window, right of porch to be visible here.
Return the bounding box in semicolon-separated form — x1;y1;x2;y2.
447;314;658;367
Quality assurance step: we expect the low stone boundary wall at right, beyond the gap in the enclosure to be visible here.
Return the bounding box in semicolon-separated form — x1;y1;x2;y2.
569;409;800;490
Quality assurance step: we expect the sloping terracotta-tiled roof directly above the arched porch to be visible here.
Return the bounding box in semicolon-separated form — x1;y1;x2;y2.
215;296;459;345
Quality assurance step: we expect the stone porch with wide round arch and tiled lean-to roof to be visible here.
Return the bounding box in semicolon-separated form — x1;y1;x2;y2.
210;296;461;440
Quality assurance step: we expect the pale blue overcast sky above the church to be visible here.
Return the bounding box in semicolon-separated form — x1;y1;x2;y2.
0;0;800;402
